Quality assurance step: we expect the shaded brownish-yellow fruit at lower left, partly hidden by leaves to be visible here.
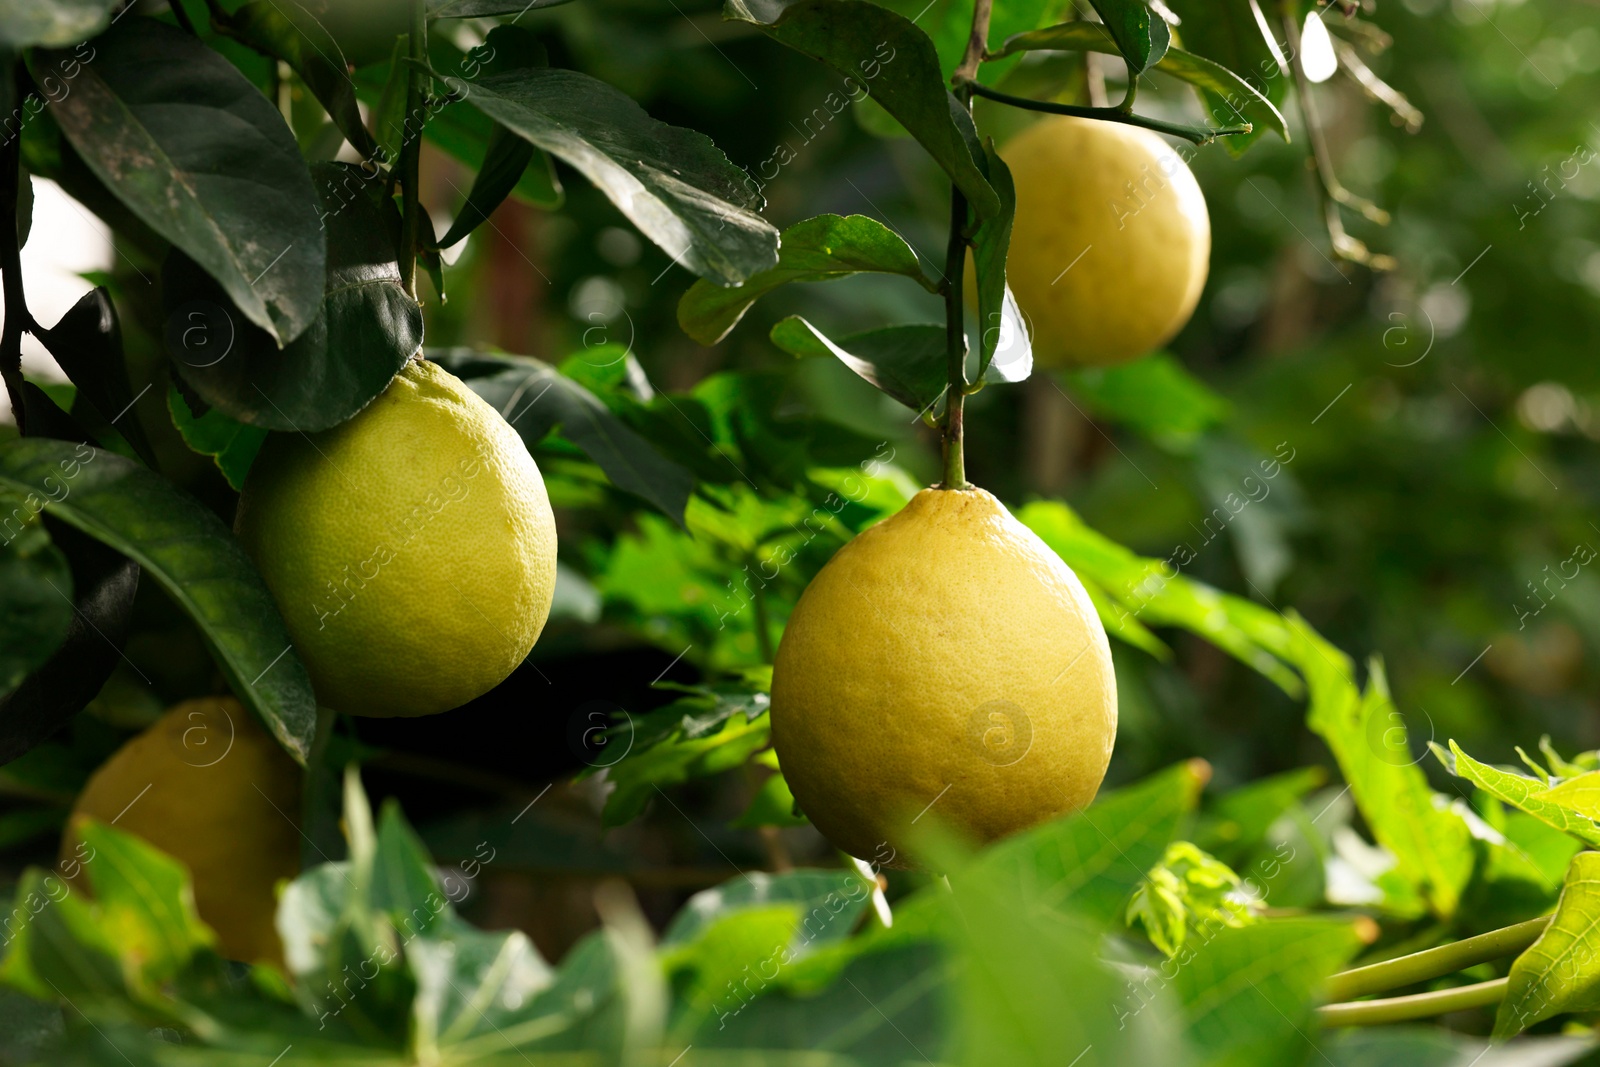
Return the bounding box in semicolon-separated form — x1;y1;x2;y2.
61;697;301;963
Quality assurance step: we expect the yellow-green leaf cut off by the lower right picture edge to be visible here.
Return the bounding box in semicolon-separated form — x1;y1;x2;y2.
1494;853;1600;1041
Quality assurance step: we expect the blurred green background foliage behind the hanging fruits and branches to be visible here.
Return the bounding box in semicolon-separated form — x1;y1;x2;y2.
0;0;1600;957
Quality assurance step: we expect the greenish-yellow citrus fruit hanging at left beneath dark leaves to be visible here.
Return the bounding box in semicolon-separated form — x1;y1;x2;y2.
235;362;555;715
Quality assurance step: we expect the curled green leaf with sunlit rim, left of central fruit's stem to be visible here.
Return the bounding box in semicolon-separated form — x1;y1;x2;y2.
678;214;933;344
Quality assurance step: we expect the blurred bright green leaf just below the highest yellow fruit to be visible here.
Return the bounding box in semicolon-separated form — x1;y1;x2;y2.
1064;352;1232;450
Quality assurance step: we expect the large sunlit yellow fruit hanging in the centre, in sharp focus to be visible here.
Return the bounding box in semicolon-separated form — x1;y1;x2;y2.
771;490;1117;865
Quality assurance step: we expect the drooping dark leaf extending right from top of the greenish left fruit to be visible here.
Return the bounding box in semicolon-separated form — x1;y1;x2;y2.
429;349;694;525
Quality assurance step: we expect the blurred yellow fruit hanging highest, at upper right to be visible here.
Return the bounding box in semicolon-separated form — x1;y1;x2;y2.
1000;115;1211;368
